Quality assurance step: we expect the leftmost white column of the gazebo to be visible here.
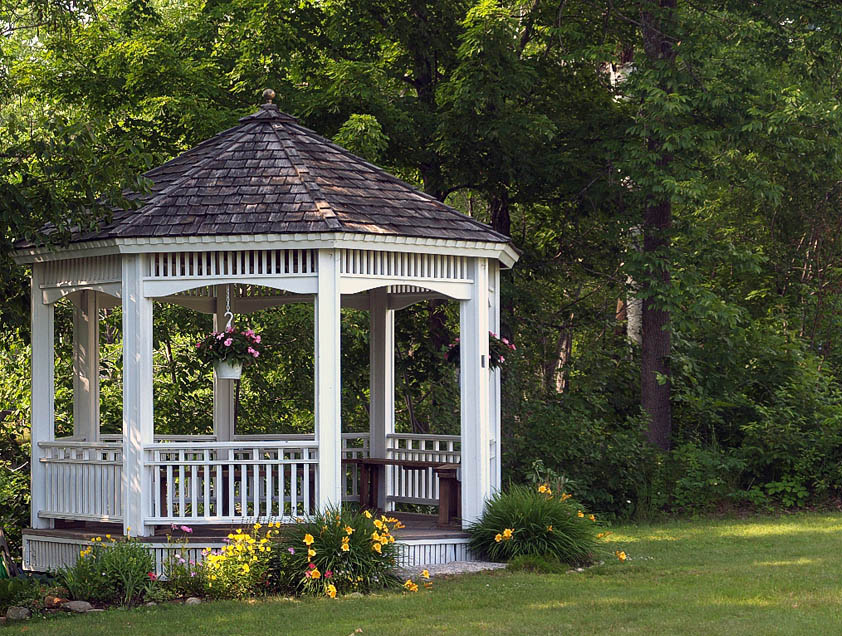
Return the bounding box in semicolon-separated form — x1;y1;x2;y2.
30;263;56;528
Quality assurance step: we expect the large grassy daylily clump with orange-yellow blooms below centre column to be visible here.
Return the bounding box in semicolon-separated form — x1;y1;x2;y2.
274;509;401;596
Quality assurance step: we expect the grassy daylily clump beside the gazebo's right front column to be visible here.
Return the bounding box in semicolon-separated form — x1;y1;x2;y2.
469;484;599;565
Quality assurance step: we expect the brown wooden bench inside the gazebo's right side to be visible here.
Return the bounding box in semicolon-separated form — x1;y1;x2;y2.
343;457;462;526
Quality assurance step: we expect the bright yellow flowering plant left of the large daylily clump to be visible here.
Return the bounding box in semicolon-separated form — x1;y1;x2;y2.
204;523;280;598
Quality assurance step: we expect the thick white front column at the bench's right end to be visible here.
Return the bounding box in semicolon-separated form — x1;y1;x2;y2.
459;258;493;527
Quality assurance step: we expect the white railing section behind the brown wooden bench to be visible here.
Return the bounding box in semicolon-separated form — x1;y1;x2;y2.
386;433;462;506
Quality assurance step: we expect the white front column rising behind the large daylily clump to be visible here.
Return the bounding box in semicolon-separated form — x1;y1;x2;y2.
314;249;342;510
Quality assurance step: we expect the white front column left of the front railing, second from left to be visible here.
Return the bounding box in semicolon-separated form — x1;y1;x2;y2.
122;254;154;536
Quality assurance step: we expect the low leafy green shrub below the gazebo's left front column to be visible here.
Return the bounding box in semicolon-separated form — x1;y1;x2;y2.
58;535;157;605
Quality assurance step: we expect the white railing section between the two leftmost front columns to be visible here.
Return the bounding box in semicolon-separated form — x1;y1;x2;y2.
38;440;123;522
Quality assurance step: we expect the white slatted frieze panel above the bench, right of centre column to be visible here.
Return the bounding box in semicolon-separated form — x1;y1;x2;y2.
340;250;470;280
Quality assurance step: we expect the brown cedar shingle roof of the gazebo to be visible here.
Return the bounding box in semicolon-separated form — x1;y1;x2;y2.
64;104;509;242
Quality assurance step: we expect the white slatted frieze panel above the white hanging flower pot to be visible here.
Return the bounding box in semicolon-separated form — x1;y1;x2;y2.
148;250;319;280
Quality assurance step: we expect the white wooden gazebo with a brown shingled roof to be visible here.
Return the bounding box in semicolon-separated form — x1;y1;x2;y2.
15;91;517;570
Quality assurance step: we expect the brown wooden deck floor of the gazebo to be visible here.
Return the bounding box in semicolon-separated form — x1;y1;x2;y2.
25;512;468;543
